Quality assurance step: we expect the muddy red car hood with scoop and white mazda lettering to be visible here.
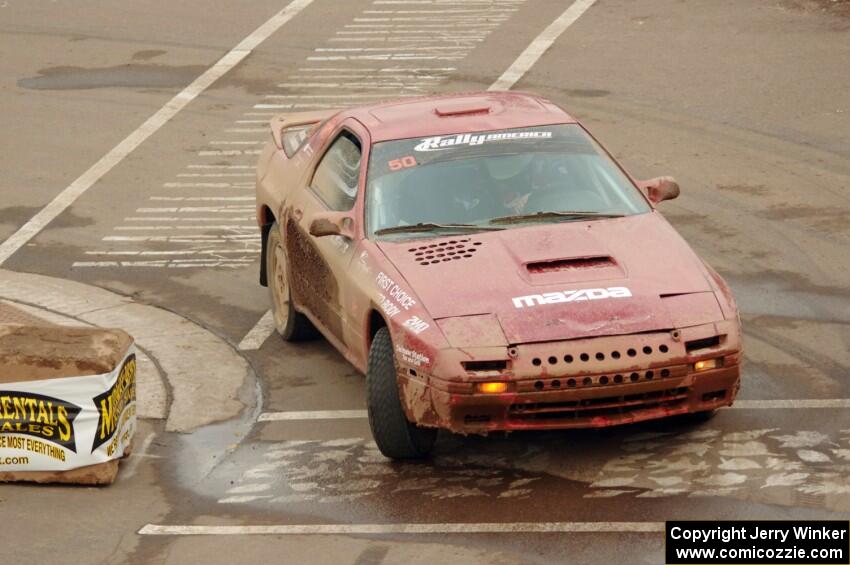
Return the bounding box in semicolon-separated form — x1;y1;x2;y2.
378;212;722;344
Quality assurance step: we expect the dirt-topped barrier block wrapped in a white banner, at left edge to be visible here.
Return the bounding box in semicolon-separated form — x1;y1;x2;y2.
0;325;136;484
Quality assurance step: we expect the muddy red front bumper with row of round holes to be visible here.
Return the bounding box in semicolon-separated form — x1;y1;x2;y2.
399;323;741;434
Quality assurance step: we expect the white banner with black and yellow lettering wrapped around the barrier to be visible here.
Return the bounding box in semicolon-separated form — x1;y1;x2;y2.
0;345;136;473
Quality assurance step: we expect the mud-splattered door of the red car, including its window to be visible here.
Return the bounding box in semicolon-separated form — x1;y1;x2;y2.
283;124;363;346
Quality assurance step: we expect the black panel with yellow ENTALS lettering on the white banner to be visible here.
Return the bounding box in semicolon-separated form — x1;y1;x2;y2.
0;391;80;453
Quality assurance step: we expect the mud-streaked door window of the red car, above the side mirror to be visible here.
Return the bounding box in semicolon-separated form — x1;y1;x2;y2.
310;131;361;212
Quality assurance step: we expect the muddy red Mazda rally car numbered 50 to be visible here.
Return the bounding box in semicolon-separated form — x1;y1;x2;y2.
257;92;742;458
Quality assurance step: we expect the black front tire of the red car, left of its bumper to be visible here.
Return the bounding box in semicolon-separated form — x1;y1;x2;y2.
366;328;437;459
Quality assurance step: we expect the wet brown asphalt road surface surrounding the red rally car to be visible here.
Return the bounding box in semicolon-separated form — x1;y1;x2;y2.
0;0;850;563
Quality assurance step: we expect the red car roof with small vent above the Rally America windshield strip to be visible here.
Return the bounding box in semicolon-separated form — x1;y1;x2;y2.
342;91;576;143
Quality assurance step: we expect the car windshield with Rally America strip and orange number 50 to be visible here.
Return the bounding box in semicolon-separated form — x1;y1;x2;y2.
366;124;650;237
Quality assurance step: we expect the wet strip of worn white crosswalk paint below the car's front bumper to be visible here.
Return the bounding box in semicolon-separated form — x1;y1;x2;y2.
212;420;850;511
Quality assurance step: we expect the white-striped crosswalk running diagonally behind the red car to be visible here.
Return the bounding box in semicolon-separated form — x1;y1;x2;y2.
73;0;525;270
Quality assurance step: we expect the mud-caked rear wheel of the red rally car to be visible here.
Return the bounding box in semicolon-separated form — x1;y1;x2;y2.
266;222;318;341
